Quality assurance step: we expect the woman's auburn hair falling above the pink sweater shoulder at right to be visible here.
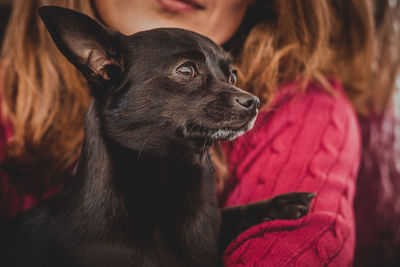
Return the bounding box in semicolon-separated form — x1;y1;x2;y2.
238;0;399;112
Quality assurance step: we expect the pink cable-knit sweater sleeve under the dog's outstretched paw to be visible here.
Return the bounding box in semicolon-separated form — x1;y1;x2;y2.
223;82;361;266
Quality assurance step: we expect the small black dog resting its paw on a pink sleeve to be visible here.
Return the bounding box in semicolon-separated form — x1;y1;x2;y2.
0;7;313;267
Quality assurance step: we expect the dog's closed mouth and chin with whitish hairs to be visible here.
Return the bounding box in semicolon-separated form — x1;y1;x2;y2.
183;113;257;141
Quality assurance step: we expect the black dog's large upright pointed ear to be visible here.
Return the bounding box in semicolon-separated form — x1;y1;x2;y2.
39;6;123;85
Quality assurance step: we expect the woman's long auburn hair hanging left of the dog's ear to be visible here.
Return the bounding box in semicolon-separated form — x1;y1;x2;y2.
0;0;92;182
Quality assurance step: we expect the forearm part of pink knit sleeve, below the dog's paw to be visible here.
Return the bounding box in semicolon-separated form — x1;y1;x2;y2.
223;212;354;267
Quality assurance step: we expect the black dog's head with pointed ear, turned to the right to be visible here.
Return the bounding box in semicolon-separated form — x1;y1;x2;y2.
39;7;259;155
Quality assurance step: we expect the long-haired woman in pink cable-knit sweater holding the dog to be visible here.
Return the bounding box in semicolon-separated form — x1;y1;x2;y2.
0;0;394;266
